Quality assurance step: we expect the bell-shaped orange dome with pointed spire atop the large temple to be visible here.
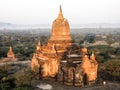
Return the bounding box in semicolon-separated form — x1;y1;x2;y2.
50;6;71;41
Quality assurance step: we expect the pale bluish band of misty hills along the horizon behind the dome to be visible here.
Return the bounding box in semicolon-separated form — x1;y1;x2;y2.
0;22;120;30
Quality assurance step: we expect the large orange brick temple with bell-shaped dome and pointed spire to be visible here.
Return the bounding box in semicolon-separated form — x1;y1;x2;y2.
31;6;98;86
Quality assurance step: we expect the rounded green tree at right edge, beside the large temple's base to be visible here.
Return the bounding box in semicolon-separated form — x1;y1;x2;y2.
101;60;120;82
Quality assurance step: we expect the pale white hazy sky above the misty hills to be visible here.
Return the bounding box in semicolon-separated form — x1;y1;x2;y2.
0;0;120;24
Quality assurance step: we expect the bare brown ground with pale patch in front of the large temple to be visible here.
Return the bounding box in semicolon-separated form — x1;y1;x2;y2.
34;80;120;90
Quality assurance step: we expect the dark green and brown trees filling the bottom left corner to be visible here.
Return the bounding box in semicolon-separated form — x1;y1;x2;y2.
0;67;33;90
